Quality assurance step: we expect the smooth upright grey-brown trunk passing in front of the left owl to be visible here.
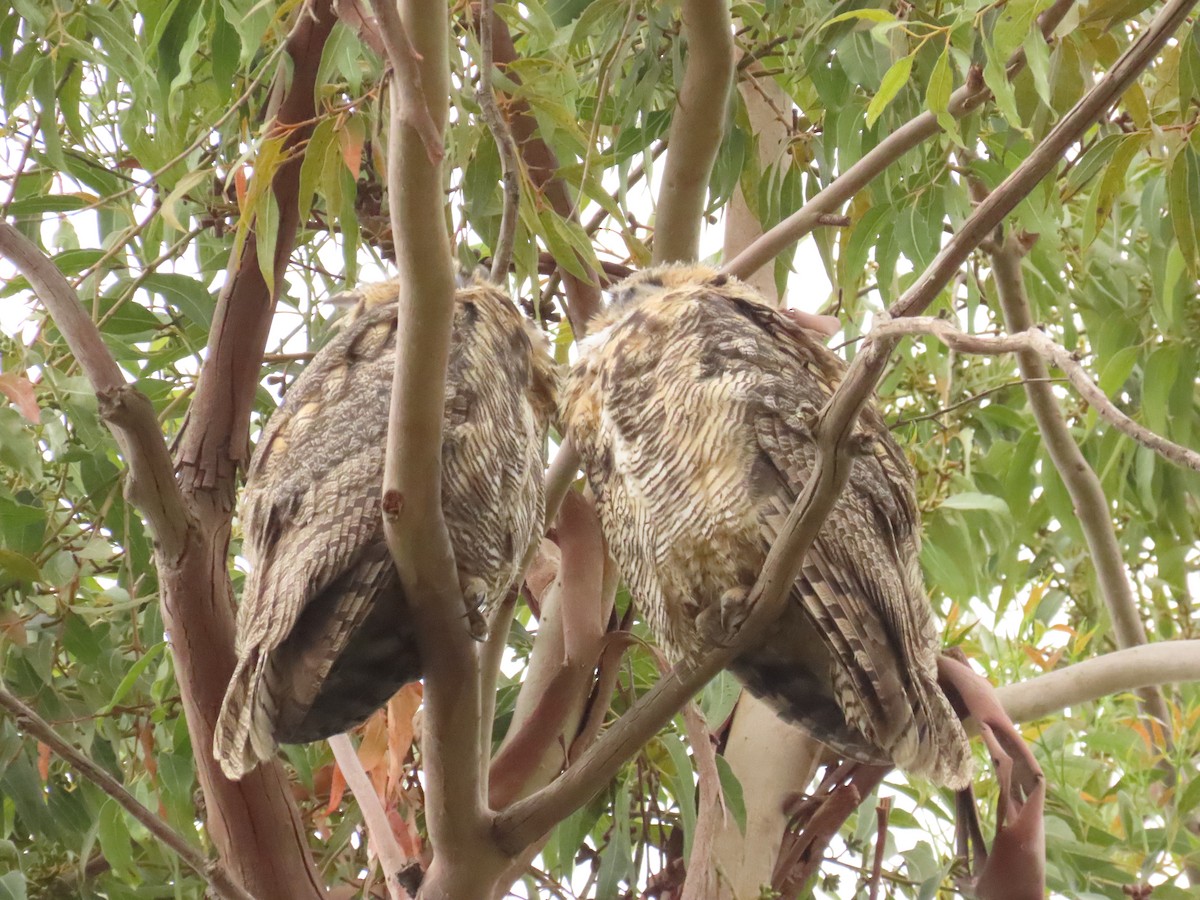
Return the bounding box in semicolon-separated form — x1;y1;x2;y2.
364;0;502;900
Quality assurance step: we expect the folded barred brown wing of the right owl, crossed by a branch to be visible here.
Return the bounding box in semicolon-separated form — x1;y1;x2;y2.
751;314;970;785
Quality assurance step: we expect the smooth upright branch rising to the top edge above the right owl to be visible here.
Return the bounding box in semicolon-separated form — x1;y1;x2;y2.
654;0;733;264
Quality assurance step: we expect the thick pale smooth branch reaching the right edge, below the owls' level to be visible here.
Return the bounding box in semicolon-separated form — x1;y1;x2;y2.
996;640;1200;722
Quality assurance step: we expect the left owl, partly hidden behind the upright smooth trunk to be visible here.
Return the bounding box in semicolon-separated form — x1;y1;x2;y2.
214;282;554;778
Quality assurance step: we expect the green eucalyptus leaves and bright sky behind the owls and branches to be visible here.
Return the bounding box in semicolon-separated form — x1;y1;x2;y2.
0;0;1200;899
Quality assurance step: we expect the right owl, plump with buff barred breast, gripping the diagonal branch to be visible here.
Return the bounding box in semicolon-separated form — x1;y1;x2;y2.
564;266;971;787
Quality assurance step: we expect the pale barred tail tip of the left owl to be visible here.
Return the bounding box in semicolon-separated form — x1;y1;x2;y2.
212;654;278;781
